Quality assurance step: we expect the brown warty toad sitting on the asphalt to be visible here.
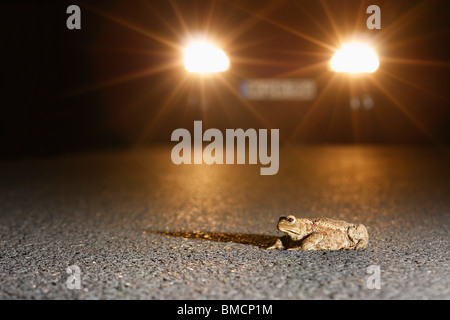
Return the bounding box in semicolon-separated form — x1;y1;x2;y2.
268;216;369;250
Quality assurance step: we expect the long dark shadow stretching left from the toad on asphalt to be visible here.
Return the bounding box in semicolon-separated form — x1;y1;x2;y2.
151;231;278;249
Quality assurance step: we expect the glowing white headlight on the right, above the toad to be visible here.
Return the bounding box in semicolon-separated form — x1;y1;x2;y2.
330;42;380;73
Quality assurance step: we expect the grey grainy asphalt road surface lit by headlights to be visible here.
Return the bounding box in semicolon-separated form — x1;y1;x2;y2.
0;145;450;299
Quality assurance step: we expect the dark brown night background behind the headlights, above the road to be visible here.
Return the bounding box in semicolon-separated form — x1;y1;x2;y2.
0;0;450;157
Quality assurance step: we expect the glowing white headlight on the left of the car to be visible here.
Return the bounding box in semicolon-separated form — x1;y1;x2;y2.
184;41;230;73
